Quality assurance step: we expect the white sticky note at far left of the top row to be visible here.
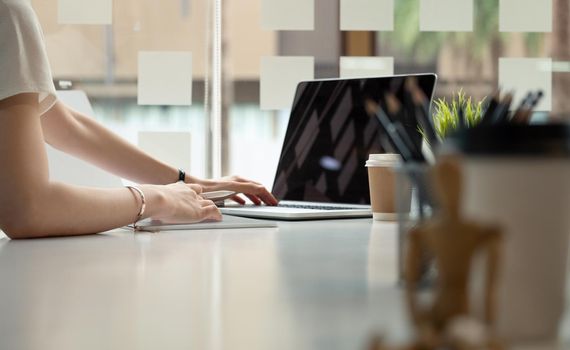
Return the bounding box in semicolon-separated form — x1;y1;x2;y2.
58;0;113;24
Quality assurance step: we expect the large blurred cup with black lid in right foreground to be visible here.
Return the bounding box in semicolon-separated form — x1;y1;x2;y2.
446;124;570;344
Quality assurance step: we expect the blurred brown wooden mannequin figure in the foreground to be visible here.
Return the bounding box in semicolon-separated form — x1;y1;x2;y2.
404;159;501;349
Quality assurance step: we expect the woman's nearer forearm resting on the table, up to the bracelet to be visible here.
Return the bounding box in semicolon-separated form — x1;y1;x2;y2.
2;183;164;238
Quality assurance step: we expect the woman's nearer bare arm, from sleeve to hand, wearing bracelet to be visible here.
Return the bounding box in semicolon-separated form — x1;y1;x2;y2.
0;94;221;238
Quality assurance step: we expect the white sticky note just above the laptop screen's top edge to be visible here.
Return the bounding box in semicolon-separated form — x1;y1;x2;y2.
340;56;394;78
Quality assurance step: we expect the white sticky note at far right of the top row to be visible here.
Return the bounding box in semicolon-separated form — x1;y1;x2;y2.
499;0;552;32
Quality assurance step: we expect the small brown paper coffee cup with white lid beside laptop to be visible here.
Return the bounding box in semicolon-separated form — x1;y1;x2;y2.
366;153;411;221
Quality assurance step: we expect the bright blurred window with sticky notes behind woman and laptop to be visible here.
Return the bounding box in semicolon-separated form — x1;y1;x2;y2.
32;0;570;187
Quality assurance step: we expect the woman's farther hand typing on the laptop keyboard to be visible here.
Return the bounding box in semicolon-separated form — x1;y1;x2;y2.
187;176;278;205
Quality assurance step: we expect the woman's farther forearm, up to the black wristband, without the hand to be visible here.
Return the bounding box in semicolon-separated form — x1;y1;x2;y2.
42;103;178;184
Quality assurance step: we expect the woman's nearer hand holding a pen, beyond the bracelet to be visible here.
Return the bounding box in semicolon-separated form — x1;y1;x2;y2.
144;182;222;223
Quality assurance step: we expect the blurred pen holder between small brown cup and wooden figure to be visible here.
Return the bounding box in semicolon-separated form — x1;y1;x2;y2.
395;162;434;282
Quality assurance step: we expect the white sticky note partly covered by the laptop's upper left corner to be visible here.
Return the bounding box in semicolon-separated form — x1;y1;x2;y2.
260;56;315;110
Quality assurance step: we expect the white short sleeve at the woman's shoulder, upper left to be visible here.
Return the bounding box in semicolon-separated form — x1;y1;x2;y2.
0;0;57;114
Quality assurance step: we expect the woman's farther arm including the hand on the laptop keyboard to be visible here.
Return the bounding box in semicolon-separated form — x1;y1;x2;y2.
42;102;277;205
